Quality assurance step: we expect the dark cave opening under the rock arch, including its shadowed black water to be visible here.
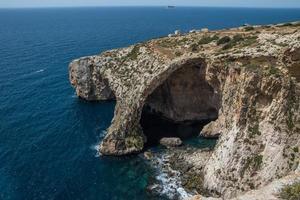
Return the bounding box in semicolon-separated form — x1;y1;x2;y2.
140;59;219;146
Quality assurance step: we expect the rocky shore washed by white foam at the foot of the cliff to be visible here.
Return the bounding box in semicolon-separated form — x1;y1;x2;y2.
144;146;212;200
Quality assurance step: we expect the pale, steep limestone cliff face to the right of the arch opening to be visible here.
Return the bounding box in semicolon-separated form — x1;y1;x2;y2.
200;57;300;195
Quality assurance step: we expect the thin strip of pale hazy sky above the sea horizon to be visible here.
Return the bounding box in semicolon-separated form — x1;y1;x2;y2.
0;0;300;8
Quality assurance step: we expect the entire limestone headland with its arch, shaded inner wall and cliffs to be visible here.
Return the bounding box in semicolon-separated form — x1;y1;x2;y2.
70;23;300;197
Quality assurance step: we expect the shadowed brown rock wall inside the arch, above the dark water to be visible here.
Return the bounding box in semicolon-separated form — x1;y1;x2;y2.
145;60;220;122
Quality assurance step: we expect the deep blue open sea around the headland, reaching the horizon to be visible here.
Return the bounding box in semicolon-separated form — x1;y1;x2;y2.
0;7;300;200
